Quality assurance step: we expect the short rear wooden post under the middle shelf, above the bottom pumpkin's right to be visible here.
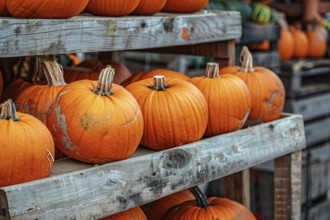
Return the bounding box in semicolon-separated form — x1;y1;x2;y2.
224;169;250;209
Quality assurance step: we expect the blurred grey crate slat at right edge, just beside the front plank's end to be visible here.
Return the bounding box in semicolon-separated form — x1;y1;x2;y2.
305;118;330;147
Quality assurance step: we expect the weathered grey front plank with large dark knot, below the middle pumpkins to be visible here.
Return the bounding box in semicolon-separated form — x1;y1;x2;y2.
0;115;306;220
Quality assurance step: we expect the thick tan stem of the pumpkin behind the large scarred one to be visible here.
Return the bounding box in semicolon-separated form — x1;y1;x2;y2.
42;61;67;86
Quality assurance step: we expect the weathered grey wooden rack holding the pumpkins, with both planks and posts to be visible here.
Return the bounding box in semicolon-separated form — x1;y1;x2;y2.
0;11;306;220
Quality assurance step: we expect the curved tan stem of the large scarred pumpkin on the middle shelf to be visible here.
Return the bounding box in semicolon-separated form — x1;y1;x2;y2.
93;66;115;96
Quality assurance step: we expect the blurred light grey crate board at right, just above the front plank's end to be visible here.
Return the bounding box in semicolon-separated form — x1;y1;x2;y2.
284;92;330;121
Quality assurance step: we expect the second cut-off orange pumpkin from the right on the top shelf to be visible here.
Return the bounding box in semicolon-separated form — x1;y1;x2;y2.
133;0;167;15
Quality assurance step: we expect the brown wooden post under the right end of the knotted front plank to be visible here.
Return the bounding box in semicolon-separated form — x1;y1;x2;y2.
274;151;301;220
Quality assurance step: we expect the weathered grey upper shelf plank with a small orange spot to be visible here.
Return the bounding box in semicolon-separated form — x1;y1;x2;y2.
0;11;242;57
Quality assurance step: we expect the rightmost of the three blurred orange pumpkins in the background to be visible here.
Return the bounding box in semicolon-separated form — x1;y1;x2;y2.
306;27;327;58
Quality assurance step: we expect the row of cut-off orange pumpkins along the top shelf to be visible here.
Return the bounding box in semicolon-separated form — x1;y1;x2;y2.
0;0;208;18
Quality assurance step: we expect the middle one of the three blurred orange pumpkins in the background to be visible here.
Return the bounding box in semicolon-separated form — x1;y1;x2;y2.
291;28;309;59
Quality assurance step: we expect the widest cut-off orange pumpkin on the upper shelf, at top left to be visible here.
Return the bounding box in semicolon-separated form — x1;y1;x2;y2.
6;0;88;18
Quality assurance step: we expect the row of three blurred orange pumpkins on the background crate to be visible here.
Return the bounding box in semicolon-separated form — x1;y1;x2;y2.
278;26;327;61
